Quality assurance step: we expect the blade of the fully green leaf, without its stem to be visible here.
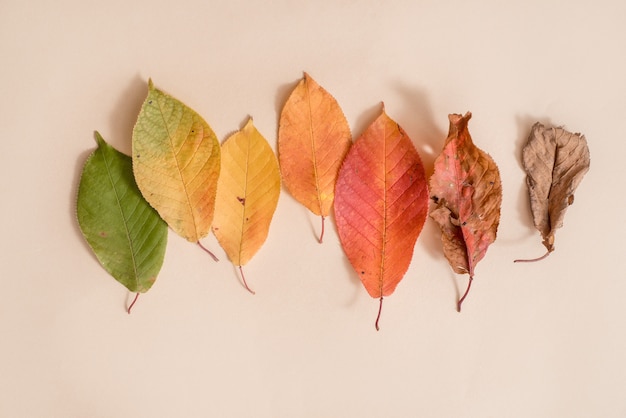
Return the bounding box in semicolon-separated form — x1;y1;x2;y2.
77;132;167;293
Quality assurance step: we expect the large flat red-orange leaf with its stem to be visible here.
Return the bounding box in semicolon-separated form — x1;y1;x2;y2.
335;109;428;329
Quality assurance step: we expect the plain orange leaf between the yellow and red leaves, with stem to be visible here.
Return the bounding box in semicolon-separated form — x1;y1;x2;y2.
278;73;352;242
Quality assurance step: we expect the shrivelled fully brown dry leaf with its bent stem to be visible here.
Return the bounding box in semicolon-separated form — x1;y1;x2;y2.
515;122;590;262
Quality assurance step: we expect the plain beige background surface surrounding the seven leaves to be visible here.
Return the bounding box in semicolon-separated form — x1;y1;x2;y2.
0;0;626;418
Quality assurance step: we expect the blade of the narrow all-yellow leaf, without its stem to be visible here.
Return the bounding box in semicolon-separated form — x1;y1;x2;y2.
213;119;280;266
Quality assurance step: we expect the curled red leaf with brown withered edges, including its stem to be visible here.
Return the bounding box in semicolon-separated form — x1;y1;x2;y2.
430;112;502;312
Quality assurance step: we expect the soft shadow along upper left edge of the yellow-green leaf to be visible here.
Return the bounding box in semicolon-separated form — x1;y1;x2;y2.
107;74;148;155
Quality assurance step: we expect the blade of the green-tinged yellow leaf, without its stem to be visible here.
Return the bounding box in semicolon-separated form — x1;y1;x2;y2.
132;80;220;242
